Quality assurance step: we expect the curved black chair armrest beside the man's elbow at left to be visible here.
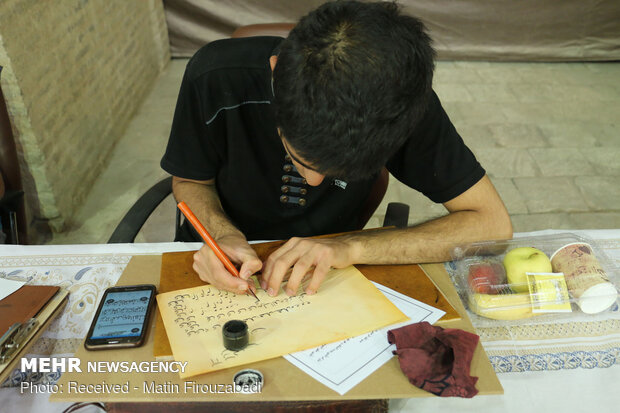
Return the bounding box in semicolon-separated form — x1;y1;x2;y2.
108;176;172;244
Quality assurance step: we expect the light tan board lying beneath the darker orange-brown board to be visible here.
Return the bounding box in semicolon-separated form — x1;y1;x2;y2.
50;256;503;402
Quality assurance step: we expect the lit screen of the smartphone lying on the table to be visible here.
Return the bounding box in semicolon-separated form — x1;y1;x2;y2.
89;289;154;344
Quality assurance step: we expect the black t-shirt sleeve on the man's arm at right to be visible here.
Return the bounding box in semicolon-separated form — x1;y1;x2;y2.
386;92;485;203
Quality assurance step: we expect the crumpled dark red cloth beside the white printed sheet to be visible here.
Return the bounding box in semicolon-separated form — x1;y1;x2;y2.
388;321;480;398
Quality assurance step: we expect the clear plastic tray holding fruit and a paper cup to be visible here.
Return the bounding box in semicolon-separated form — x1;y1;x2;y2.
452;233;620;321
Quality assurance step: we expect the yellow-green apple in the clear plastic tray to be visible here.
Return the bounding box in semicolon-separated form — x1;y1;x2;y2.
504;247;553;293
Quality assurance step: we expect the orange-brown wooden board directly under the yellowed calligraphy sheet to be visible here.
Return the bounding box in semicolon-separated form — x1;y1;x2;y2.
153;241;460;359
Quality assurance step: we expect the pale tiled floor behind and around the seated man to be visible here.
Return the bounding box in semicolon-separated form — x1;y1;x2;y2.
52;60;620;244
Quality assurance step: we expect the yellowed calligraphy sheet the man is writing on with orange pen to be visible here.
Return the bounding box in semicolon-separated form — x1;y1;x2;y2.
157;266;407;379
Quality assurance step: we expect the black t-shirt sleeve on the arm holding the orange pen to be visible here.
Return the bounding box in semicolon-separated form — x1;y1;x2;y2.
161;60;220;180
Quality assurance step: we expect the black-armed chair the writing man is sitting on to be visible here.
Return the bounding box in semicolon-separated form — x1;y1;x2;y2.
108;23;409;243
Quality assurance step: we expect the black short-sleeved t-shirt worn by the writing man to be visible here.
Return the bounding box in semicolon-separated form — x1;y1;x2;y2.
161;37;485;240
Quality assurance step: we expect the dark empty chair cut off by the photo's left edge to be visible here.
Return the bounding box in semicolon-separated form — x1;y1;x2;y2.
0;66;27;244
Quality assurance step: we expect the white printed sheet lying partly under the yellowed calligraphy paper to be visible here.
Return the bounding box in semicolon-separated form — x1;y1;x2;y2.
284;283;445;395
